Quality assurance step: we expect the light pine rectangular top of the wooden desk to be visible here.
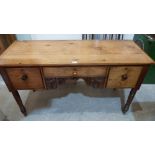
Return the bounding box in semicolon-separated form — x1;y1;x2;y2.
0;40;153;66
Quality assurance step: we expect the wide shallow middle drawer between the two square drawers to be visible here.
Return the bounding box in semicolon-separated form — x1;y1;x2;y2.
43;67;107;78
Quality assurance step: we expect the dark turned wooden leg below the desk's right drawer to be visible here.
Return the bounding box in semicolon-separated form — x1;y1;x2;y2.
122;88;137;113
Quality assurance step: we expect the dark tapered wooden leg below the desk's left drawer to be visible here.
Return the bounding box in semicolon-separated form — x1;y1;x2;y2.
12;90;27;116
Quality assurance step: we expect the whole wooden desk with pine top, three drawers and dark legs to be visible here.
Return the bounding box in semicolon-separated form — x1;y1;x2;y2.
0;41;154;115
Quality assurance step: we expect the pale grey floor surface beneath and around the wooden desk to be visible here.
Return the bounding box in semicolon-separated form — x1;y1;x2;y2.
0;75;155;121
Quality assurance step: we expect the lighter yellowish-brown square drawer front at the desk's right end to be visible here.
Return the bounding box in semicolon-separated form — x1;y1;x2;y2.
107;66;143;88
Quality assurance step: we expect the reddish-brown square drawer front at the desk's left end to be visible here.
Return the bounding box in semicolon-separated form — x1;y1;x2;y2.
6;68;43;89
